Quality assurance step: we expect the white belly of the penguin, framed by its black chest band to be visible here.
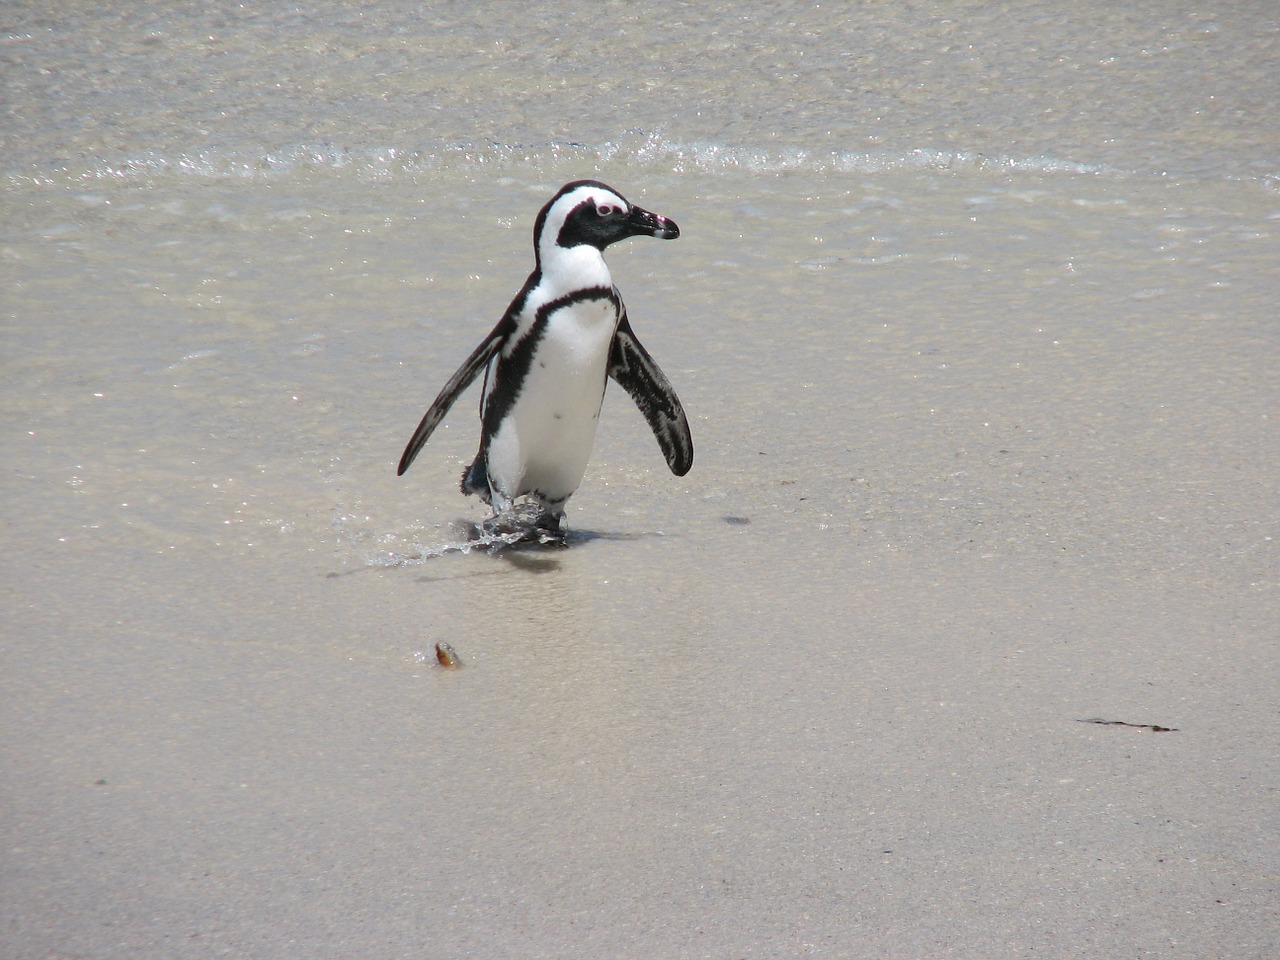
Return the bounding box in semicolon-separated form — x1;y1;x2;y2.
489;298;618;502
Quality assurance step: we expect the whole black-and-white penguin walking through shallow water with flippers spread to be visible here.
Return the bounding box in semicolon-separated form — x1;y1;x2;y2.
397;180;694;539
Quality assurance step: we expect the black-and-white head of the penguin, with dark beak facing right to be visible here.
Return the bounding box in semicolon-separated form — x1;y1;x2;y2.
534;180;680;262
